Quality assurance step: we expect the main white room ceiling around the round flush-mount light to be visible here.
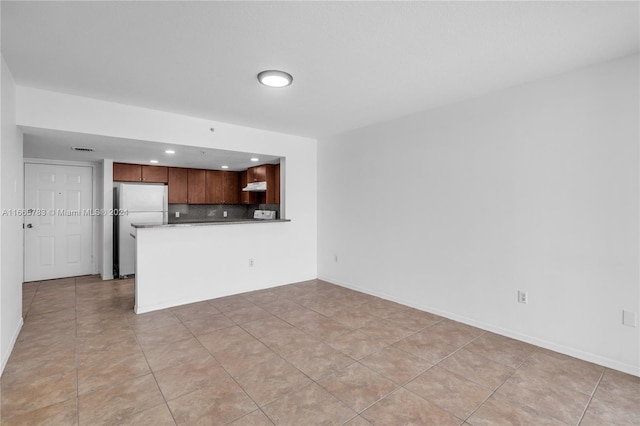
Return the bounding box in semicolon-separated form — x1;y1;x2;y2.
1;1;639;141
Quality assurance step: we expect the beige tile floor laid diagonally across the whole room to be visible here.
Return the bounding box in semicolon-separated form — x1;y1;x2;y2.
1;277;640;426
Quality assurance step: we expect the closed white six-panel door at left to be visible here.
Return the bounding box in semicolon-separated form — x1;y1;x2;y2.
24;164;93;281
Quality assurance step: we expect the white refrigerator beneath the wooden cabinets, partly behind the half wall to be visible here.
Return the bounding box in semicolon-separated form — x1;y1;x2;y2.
115;183;169;277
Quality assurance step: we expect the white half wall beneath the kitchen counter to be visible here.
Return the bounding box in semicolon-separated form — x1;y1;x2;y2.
132;219;304;314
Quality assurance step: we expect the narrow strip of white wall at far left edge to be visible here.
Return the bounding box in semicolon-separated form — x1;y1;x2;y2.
0;56;24;371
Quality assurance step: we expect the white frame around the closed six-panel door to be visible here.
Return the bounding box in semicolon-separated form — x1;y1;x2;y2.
22;158;100;276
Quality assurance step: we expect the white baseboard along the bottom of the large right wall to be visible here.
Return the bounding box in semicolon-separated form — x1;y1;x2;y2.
318;276;640;377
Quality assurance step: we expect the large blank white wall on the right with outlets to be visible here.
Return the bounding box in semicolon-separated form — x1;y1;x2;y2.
318;56;640;375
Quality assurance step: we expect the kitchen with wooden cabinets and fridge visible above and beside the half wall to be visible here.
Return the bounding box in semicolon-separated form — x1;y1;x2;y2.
113;160;282;278
